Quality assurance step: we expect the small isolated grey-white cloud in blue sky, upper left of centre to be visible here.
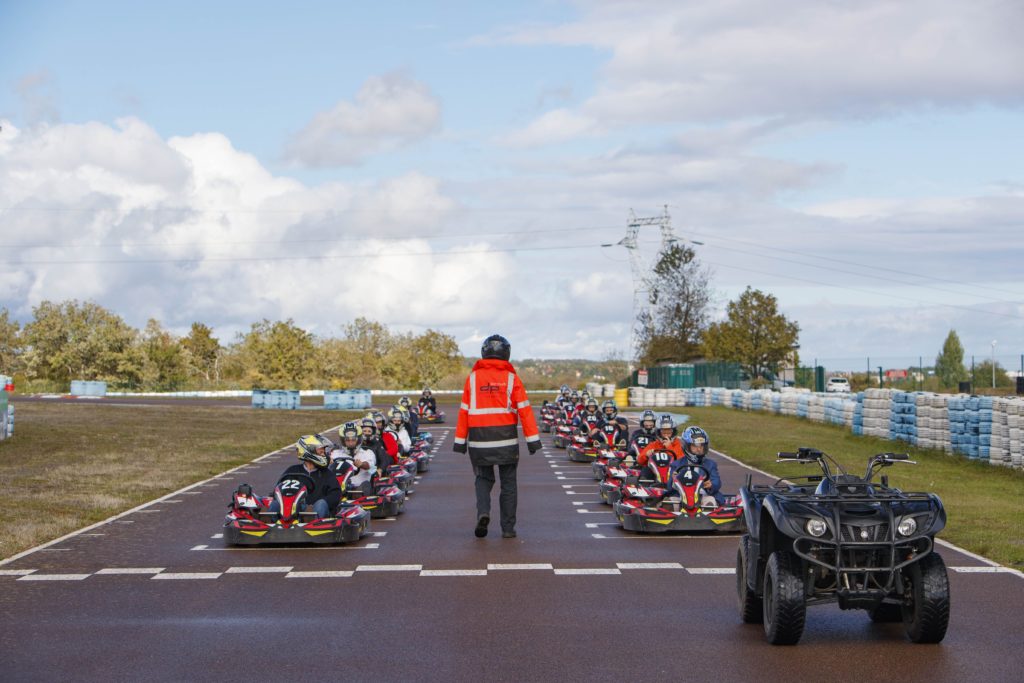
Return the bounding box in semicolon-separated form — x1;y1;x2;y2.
286;73;441;167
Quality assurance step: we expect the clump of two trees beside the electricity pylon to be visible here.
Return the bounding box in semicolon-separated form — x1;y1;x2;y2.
635;243;800;386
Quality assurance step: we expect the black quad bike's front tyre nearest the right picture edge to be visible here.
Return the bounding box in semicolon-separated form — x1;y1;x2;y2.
903;552;949;643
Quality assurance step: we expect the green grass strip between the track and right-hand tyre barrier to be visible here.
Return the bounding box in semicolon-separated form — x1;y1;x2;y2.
678;407;1024;568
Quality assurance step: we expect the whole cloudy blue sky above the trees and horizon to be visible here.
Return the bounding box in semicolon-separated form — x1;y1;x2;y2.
0;0;1024;365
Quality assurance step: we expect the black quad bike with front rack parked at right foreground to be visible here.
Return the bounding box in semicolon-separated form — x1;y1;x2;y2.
736;449;949;645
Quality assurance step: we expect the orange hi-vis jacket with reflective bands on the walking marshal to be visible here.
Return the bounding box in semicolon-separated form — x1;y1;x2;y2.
455;358;541;467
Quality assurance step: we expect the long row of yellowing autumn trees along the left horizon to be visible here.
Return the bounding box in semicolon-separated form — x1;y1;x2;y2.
0;300;464;391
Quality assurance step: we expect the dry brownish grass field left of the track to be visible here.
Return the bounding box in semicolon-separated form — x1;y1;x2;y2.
0;401;355;558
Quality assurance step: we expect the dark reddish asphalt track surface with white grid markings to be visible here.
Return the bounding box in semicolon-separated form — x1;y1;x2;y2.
0;413;1024;682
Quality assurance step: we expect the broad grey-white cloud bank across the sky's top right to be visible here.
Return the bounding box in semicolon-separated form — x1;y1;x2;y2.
501;0;1024;139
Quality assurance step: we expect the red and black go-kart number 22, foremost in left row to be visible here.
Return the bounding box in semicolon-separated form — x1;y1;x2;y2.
223;473;370;546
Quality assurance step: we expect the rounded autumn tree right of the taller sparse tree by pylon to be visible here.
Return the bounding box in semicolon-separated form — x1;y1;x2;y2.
702;287;800;383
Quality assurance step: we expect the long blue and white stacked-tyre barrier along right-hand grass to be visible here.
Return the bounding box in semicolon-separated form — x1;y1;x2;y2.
629;387;1024;469
